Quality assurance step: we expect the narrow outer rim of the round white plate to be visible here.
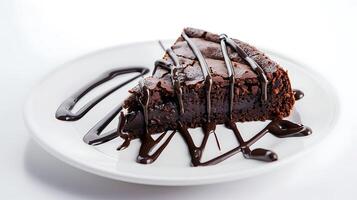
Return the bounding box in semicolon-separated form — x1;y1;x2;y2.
23;40;341;186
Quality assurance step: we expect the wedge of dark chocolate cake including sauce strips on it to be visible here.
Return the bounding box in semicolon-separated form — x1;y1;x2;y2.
122;28;295;134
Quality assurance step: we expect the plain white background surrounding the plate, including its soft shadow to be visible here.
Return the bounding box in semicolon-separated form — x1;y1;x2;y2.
0;0;357;200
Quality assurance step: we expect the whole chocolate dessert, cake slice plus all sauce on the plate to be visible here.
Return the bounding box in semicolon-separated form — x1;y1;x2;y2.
56;28;311;166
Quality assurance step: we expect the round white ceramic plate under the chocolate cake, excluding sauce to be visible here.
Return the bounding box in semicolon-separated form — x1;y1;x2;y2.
25;41;339;185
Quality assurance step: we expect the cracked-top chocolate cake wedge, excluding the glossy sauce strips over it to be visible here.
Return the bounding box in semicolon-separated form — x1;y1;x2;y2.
123;28;295;133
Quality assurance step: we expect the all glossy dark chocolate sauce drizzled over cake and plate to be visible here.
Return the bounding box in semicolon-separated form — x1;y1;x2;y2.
56;32;312;166
